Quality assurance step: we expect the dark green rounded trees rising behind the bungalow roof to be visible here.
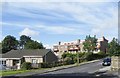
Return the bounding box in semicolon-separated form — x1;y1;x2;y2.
2;35;44;53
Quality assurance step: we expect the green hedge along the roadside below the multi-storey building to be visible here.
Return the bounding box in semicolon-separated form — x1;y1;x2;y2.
62;52;108;64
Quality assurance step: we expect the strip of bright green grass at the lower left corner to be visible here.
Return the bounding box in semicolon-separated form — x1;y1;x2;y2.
0;70;31;76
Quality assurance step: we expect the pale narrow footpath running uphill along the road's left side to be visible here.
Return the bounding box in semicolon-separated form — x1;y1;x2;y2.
4;60;99;76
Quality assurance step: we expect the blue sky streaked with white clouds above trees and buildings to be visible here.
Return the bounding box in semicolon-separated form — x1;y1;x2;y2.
0;0;118;48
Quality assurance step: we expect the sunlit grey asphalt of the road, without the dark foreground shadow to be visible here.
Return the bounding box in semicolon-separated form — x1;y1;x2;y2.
40;61;103;75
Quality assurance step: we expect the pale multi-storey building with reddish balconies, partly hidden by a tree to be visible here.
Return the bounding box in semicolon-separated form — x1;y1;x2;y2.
53;36;108;58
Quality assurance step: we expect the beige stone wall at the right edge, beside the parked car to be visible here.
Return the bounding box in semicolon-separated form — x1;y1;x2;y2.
111;56;120;71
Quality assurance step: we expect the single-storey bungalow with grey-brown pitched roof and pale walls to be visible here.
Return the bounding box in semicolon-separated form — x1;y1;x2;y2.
2;49;58;69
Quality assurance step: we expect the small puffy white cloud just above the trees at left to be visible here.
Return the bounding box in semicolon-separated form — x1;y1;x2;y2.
19;28;39;36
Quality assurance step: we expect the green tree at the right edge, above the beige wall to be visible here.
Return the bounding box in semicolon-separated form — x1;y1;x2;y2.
108;38;120;56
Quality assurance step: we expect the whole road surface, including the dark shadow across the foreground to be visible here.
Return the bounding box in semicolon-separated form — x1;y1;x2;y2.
2;60;118;78
